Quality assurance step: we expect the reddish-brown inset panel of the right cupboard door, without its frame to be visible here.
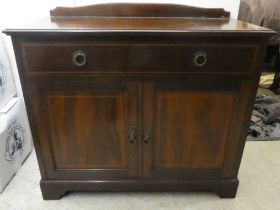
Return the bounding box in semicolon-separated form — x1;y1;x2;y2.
153;92;235;169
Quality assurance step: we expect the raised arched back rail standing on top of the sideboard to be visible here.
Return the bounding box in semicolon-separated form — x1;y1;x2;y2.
50;3;230;18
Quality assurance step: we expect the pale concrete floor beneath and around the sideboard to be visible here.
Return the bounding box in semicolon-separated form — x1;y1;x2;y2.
0;141;280;210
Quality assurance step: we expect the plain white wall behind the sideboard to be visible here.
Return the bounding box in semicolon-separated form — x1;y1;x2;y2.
0;0;240;96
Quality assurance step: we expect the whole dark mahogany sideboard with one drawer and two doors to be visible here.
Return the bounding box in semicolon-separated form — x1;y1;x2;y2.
4;4;275;200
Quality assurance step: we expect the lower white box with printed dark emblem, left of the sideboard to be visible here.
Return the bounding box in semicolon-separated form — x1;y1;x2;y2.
0;98;33;192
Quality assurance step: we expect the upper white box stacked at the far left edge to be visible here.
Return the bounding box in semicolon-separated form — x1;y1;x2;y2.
0;35;16;109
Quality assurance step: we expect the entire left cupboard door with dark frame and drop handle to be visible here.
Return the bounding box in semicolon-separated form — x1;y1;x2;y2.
29;80;138;179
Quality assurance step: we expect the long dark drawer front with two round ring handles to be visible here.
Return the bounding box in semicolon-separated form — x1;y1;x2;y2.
22;42;257;75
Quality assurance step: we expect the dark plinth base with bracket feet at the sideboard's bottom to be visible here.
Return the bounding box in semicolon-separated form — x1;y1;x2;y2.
40;179;239;200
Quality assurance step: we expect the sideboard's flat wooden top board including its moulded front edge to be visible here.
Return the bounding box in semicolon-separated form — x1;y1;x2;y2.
3;17;276;38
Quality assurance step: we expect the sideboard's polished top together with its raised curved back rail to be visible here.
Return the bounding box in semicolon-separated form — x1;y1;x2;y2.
4;4;275;36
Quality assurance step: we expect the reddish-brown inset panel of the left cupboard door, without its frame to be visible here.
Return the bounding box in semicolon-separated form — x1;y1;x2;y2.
47;92;128;169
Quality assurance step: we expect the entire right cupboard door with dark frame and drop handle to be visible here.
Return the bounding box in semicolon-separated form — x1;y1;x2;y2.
142;78;247;178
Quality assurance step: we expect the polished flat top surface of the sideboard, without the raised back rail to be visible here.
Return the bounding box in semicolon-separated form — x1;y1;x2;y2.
4;17;274;35
